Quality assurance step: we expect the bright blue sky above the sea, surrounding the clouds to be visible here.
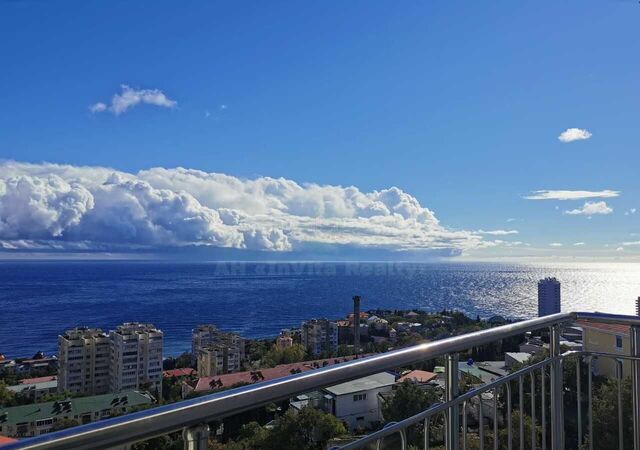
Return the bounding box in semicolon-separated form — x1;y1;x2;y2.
0;0;640;259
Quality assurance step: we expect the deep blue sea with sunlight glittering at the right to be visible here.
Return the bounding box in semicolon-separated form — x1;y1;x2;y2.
0;261;640;357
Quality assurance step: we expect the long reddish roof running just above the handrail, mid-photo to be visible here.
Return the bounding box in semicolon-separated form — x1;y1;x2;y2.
194;355;369;392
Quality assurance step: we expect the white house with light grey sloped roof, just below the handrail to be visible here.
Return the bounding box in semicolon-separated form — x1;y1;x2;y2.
322;372;396;431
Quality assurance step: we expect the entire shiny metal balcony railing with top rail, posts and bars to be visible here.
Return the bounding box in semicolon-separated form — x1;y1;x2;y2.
3;313;640;450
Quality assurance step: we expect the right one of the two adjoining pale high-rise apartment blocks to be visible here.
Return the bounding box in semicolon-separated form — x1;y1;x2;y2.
109;322;163;395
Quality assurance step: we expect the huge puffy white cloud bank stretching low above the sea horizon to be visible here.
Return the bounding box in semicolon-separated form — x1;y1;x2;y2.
0;161;484;255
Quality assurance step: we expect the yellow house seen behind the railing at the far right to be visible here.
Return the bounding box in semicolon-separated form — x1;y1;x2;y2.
578;321;631;378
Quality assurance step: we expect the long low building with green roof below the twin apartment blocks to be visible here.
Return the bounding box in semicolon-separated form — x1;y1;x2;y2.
0;391;155;438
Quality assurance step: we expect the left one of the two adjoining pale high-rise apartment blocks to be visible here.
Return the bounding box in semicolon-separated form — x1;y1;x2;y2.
58;328;111;395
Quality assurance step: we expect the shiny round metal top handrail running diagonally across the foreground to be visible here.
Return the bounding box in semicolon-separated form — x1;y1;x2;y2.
4;313;596;450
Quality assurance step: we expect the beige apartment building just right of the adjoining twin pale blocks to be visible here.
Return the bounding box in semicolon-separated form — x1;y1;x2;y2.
191;324;245;377
